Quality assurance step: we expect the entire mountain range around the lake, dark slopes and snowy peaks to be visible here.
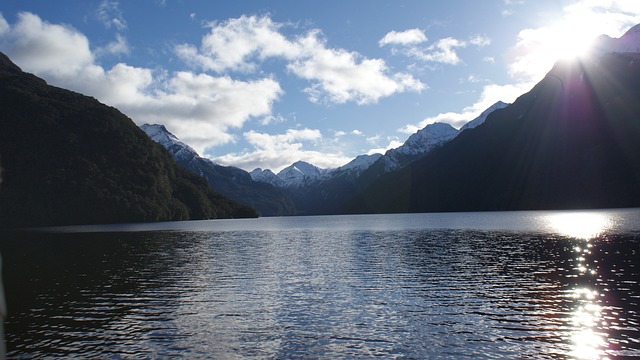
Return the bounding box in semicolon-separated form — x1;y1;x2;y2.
0;25;640;227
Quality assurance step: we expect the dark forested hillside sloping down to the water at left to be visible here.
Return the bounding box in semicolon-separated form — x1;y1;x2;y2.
0;53;257;227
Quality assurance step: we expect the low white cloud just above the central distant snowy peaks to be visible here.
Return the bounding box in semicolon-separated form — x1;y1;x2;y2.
213;128;351;172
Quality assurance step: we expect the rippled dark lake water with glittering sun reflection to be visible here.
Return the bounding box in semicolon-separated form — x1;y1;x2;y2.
0;209;640;359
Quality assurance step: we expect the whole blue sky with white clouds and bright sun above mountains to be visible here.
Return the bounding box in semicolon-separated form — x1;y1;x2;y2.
0;0;640;172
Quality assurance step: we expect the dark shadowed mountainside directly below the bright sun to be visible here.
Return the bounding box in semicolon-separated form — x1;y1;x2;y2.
346;54;640;212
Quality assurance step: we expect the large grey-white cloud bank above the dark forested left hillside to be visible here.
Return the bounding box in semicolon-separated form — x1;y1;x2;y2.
0;13;283;153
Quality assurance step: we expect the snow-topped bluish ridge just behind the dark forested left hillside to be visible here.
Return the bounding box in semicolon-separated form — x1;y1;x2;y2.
140;124;296;216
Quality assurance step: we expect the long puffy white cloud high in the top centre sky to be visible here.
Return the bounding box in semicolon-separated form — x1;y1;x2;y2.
175;16;426;105
